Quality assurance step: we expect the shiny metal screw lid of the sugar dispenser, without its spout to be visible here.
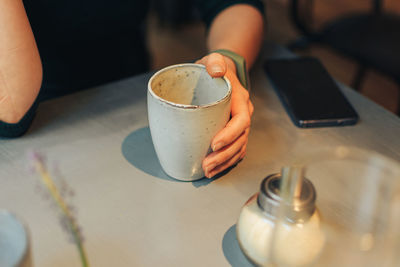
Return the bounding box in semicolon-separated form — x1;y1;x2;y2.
257;173;316;223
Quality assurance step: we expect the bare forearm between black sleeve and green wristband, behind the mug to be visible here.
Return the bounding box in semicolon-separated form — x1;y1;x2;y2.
207;4;264;68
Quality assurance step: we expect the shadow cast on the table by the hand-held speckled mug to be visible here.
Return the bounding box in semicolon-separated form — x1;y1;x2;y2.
122;127;223;187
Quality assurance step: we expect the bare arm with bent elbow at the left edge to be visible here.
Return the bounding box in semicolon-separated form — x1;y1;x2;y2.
0;0;42;123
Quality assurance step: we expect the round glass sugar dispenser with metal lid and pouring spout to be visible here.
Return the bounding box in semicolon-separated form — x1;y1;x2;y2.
236;166;325;267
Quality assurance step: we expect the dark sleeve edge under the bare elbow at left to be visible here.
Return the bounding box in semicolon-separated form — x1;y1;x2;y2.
0;100;39;138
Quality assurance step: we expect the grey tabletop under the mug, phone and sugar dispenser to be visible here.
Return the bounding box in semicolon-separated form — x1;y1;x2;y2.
0;44;400;267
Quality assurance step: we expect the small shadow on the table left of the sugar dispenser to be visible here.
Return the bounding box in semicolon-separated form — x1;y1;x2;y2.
222;224;254;267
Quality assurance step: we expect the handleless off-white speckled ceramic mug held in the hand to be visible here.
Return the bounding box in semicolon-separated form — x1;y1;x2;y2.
147;64;232;181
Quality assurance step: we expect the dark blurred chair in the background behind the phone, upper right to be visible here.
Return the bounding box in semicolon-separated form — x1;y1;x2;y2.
289;0;400;115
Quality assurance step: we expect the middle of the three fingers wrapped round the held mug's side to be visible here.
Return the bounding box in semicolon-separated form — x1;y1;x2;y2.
203;129;249;173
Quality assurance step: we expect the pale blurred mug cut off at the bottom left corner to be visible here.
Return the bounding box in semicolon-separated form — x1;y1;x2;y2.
0;210;32;267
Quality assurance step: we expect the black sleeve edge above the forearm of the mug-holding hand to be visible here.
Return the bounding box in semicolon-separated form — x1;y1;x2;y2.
196;0;265;29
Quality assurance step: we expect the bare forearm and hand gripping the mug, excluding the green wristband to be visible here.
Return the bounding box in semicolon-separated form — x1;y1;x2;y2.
200;4;264;177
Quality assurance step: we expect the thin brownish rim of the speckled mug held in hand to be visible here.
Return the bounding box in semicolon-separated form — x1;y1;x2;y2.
147;63;232;109
